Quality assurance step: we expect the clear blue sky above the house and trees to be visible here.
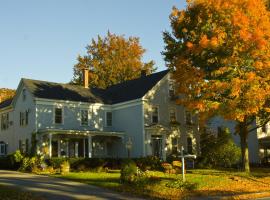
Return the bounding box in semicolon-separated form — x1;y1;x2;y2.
0;0;185;88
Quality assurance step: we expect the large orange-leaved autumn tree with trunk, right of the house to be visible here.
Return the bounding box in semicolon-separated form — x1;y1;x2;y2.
163;0;270;171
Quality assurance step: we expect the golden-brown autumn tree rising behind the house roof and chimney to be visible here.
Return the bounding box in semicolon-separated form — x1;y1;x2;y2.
72;32;155;88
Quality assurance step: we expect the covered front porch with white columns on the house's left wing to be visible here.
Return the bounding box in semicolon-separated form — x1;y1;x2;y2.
38;129;124;158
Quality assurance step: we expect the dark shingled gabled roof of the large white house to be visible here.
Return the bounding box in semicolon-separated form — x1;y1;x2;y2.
0;70;169;108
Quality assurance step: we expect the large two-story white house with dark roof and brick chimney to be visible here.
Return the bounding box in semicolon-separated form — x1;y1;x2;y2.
0;70;199;160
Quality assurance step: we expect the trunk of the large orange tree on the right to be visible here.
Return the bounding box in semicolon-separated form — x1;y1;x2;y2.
239;122;250;172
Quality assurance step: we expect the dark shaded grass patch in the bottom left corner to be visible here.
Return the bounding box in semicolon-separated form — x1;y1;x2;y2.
0;185;41;200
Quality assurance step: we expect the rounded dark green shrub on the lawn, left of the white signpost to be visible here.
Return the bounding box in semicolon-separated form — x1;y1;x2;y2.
120;159;138;183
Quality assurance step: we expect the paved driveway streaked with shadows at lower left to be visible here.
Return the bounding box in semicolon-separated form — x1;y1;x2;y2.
0;170;143;200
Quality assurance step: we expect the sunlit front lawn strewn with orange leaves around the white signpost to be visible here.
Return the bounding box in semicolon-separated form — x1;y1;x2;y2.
55;169;270;199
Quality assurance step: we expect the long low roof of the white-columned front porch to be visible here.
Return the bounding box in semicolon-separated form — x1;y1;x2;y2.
37;129;125;137
